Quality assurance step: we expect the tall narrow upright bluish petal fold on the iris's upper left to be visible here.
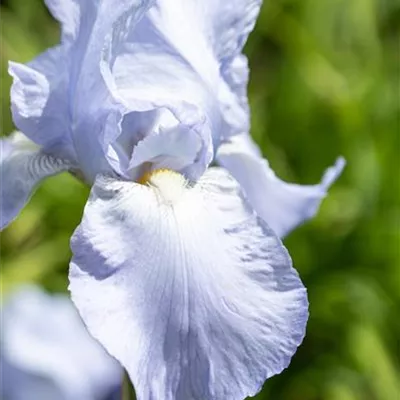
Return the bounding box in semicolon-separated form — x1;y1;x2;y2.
69;0;151;181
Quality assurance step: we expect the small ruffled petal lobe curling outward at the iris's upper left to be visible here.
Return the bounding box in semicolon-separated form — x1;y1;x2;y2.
8;47;75;159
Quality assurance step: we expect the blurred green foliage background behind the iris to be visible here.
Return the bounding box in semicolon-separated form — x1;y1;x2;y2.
0;0;400;400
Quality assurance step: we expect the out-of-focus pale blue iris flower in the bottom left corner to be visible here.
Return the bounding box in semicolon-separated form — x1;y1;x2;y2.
0;286;122;400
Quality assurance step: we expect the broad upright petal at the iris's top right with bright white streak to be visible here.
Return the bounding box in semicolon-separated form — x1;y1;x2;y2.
102;0;261;170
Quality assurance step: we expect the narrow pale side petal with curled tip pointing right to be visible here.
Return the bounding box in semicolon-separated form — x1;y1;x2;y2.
217;135;345;237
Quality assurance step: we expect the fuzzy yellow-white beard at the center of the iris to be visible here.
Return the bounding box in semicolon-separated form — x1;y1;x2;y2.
138;168;188;205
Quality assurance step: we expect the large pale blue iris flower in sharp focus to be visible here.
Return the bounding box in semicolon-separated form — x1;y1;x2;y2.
1;0;344;400
